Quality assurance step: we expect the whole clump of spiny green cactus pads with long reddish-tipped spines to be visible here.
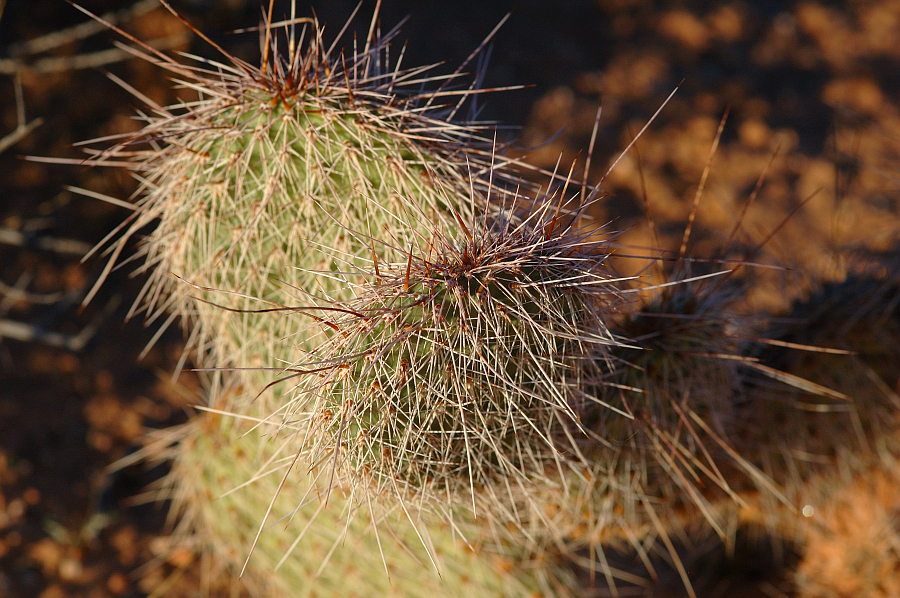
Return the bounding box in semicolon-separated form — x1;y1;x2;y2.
75;2;900;596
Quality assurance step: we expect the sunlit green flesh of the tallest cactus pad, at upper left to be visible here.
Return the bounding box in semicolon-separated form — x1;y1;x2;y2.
134;94;474;390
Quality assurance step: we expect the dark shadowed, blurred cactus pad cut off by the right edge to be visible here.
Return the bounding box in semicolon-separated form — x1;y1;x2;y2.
740;264;900;542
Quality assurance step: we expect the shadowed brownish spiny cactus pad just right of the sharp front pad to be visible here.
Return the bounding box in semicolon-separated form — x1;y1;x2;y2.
539;261;777;596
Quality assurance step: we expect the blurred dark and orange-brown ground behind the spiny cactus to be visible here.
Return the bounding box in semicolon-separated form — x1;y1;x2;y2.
0;0;900;598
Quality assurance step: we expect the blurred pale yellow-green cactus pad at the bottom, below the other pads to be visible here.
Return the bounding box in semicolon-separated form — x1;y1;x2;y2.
141;384;573;598
